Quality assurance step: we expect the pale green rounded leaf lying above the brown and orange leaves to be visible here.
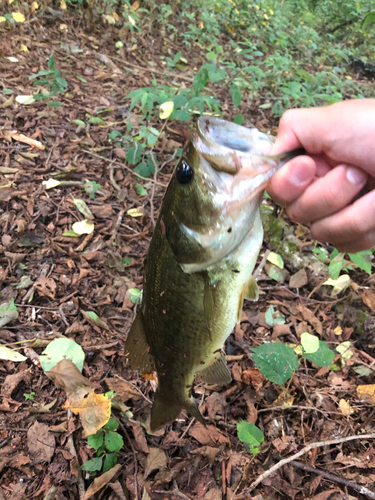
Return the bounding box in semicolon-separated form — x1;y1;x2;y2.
39;338;85;372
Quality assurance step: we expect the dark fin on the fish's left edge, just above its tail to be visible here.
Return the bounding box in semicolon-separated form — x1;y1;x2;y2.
125;311;155;372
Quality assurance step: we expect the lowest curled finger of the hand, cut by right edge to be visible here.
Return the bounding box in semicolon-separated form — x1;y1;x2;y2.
311;191;375;249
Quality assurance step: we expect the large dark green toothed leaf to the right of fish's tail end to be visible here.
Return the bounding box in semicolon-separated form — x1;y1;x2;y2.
251;342;299;385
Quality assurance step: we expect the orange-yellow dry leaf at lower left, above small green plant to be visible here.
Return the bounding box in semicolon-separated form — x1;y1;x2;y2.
63;390;111;436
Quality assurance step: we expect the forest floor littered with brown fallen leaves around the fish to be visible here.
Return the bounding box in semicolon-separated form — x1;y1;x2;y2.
0;10;375;500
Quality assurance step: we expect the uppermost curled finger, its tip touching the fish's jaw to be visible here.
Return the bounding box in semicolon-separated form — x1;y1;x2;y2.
267;156;316;205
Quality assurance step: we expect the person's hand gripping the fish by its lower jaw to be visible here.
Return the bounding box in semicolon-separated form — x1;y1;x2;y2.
267;99;375;253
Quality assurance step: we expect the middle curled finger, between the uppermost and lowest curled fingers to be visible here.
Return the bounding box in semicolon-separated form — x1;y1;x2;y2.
287;165;368;224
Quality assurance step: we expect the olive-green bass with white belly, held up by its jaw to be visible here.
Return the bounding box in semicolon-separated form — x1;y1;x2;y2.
125;115;303;432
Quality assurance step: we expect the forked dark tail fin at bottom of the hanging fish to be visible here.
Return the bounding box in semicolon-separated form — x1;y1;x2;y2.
150;389;206;432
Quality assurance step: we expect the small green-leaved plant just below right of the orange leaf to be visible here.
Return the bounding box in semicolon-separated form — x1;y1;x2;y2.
81;418;124;474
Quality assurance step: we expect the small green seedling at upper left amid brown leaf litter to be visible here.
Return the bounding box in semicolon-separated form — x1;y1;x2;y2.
29;53;68;108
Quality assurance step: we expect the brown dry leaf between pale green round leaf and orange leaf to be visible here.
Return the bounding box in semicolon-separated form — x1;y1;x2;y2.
45;359;94;395
